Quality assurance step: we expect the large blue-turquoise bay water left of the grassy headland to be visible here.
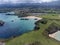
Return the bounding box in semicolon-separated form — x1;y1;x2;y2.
0;13;36;39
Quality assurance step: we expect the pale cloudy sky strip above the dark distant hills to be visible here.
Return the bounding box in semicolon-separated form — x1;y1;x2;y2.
0;0;58;4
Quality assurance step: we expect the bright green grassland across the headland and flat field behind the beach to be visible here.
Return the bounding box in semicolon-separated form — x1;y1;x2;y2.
6;14;60;45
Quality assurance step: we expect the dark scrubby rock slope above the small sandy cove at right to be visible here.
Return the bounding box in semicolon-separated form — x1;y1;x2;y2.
46;23;60;34
